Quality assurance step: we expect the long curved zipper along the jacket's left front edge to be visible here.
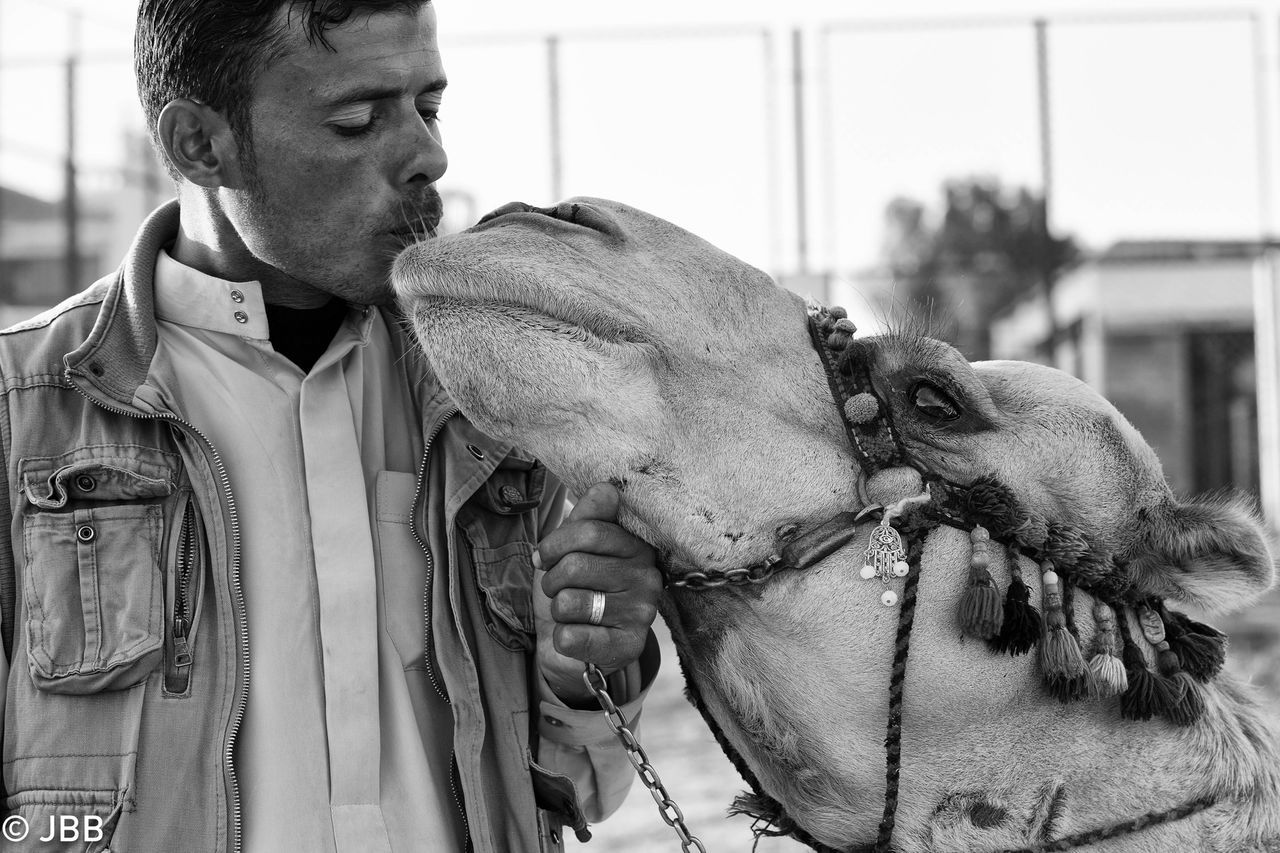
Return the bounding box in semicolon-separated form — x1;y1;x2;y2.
64;368;250;853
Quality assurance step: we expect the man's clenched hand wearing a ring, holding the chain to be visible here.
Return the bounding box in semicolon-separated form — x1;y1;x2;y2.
534;483;662;702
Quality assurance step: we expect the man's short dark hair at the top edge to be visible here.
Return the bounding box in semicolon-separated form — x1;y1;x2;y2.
133;0;430;178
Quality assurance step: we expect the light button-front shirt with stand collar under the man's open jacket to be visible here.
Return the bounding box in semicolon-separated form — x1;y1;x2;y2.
152;252;462;853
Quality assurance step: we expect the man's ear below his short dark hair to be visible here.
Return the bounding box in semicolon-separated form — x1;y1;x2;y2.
156;97;243;188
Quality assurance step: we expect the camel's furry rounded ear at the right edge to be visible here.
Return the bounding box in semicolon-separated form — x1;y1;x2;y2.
1129;500;1276;612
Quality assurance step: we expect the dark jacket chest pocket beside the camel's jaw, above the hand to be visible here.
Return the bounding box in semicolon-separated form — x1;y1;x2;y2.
458;453;547;651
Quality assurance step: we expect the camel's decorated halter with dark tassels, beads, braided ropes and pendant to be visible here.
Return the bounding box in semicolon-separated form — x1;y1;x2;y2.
669;306;1226;853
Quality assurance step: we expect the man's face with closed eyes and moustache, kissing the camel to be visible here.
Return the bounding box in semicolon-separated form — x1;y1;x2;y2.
223;4;448;304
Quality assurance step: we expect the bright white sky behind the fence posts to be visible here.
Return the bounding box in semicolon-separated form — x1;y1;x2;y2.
0;0;1277;279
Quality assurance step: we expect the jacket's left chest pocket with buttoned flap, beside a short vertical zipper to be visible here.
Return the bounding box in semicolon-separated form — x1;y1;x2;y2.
19;447;178;694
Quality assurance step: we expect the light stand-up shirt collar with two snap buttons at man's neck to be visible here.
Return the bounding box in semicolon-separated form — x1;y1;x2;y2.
155;248;271;341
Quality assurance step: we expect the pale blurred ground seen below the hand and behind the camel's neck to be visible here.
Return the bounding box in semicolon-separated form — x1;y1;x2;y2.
581;590;1280;853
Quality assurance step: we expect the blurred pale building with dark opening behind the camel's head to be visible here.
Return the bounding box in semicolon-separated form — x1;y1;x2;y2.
991;235;1262;494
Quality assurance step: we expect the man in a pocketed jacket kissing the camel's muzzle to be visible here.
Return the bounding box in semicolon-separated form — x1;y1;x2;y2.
0;0;660;853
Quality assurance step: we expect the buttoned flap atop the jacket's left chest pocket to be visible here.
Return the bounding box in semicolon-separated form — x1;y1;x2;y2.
18;446;179;510
